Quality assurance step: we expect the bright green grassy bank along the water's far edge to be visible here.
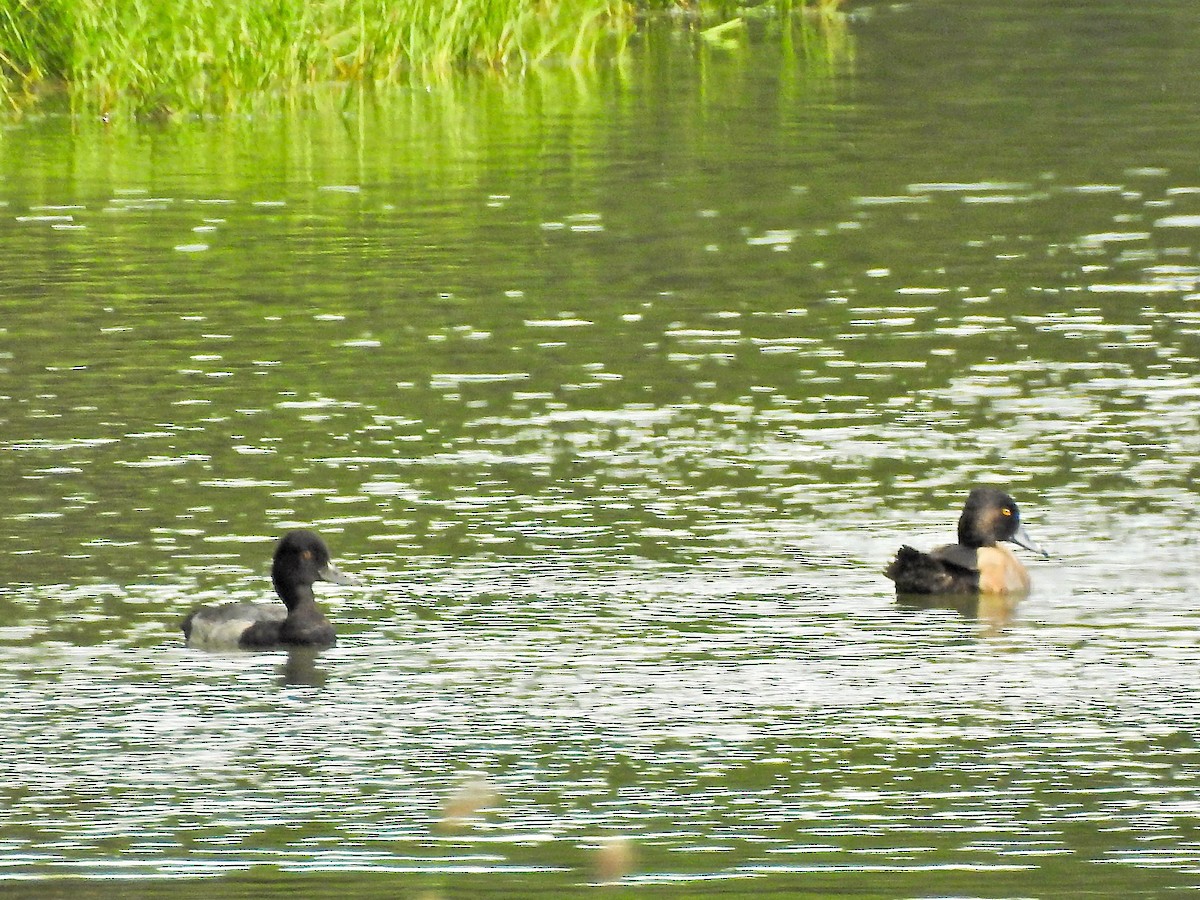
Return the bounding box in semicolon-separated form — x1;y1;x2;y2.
0;0;839;113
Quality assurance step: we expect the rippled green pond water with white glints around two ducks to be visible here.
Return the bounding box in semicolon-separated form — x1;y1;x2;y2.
0;0;1200;898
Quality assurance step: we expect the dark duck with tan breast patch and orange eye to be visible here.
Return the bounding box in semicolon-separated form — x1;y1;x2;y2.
883;487;1049;598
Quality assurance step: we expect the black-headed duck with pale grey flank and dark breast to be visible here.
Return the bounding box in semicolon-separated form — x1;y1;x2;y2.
182;528;356;650
